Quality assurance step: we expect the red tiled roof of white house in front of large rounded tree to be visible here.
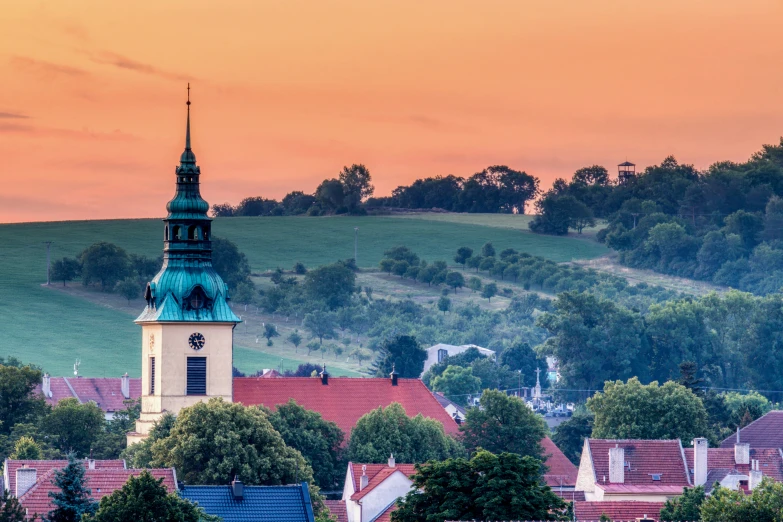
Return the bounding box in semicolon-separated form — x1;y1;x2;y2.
588;439;689;486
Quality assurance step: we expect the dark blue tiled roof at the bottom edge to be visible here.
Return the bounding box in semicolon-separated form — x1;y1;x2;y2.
179;482;314;522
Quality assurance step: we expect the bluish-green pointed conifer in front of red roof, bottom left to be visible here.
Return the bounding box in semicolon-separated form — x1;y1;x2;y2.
46;453;98;522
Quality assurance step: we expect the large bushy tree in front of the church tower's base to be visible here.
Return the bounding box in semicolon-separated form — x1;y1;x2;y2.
152;398;313;486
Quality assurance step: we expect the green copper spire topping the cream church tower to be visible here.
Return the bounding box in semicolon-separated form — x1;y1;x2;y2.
136;84;239;323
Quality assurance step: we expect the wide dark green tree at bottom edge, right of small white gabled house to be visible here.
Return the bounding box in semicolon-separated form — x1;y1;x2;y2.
391;450;569;522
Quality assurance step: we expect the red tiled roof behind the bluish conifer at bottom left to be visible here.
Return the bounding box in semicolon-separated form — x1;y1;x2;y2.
19;469;177;519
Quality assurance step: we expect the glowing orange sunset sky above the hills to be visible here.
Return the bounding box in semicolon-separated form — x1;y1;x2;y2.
0;0;783;222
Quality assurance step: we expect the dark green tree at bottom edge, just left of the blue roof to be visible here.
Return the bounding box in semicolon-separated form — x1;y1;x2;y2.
84;470;220;522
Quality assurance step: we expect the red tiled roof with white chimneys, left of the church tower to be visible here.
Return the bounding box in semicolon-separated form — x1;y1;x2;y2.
35;377;141;412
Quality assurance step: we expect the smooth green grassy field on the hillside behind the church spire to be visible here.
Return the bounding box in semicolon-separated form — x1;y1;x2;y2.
0;214;607;377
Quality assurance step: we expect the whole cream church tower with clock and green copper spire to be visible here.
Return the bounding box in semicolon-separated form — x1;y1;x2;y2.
128;85;240;444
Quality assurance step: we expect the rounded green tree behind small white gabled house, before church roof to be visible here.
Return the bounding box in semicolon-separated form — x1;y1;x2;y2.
347;402;464;464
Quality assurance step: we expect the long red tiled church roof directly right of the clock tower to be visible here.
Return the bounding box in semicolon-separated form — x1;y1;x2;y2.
234;377;459;434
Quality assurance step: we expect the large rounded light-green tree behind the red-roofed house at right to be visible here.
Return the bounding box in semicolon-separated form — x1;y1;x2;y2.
587;377;708;440
